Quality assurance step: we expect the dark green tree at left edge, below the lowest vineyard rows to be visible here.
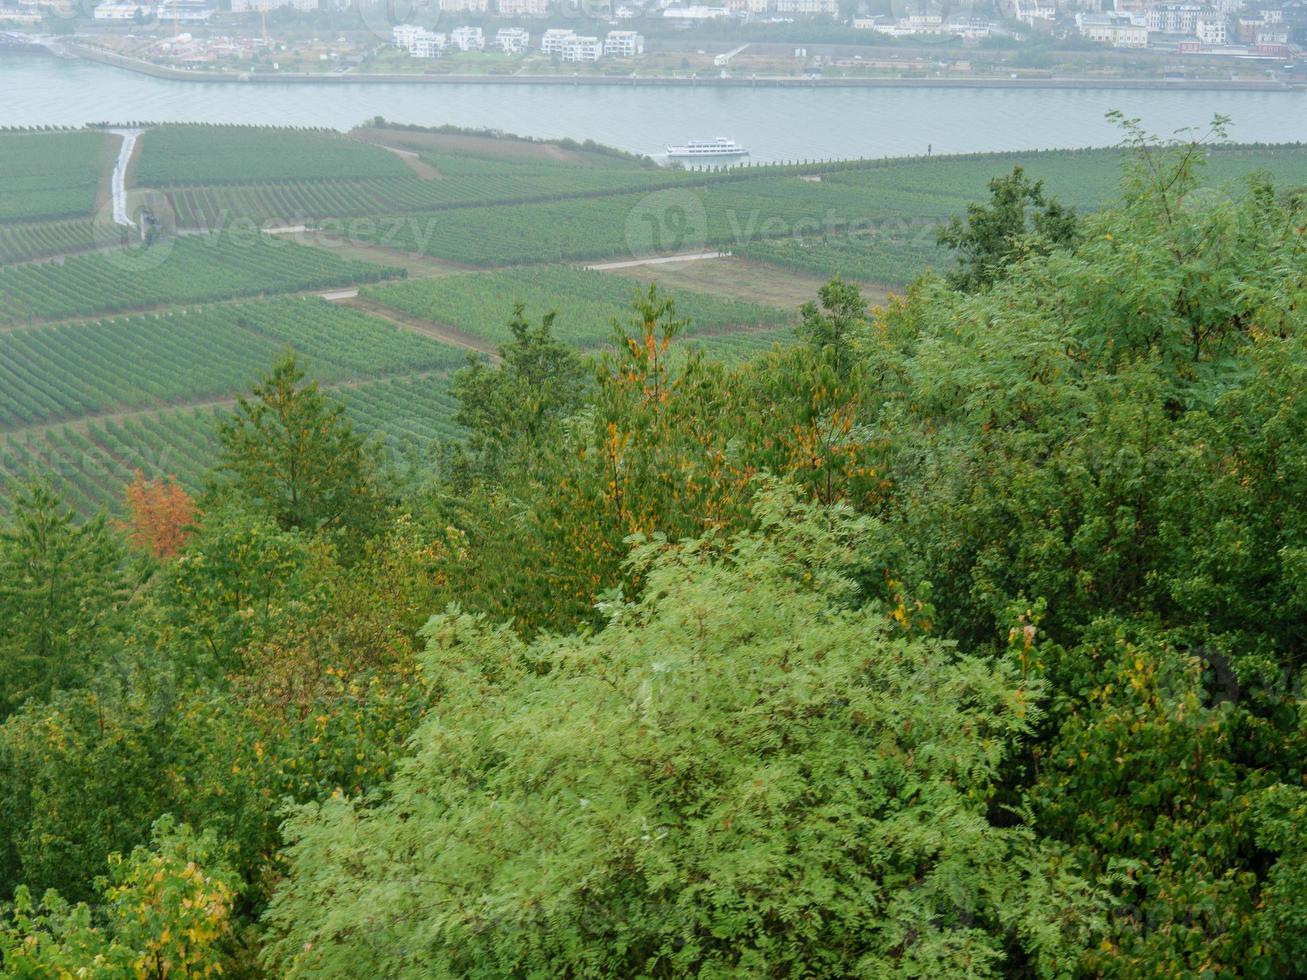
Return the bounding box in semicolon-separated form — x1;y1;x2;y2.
0;486;127;719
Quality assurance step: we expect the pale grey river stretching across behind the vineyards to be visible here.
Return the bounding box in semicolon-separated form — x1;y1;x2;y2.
0;50;1307;161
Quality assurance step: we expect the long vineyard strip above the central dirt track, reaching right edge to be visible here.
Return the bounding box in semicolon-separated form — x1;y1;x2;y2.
347;146;1307;265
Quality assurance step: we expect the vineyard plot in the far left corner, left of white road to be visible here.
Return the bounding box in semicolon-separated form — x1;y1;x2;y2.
0;132;107;222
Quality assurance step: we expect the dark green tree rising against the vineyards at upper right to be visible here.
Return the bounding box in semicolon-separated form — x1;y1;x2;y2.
940;166;1078;293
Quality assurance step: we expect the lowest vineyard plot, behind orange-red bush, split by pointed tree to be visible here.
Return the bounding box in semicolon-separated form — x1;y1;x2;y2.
0;375;459;515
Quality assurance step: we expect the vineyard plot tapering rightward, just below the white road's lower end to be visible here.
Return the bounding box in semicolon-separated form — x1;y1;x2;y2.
0;233;404;324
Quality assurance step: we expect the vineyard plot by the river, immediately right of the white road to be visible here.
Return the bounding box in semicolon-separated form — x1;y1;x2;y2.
135;125;410;187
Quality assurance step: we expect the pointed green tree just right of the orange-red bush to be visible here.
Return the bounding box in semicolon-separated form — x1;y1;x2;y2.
218;354;383;533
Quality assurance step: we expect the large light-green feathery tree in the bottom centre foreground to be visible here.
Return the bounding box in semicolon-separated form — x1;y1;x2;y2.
268;489;1099;977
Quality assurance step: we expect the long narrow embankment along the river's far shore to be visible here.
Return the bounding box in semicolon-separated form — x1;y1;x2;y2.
58;42;1307;91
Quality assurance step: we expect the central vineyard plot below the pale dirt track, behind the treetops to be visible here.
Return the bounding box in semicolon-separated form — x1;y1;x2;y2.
361;267;791;348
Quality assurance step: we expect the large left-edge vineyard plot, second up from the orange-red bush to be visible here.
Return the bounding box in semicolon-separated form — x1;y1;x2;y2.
0;298;465;430
